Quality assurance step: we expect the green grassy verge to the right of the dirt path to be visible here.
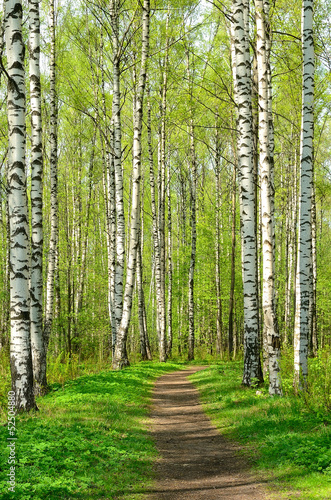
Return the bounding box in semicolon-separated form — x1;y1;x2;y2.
190;362;331;500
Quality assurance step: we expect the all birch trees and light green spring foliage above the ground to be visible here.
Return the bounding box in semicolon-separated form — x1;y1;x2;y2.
0;0;331;409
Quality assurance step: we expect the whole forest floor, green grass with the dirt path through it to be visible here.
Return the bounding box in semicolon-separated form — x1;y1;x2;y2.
0;358;331;500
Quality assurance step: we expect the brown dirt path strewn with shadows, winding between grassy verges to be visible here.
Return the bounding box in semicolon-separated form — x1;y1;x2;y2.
146;367;266;500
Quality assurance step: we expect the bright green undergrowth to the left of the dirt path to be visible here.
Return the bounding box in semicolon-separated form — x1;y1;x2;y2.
0;363;182;500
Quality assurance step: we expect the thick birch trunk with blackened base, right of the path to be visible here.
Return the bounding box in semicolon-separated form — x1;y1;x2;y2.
232;0;263;386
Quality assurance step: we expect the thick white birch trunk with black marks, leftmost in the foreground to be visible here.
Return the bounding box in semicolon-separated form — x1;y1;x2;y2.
5;0;36;412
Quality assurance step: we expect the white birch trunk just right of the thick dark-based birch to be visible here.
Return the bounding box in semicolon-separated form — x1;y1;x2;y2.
255;0;282;395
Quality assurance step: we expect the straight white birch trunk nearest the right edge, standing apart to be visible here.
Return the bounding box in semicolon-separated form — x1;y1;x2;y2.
294;0;315;390
